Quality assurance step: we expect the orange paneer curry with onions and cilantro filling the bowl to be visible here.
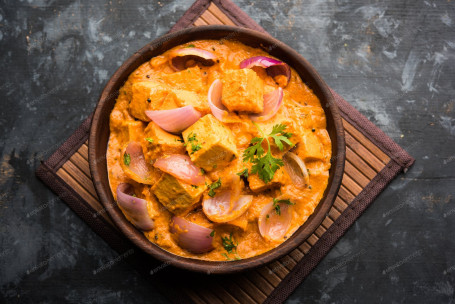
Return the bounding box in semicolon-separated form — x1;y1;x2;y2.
107;40;332;261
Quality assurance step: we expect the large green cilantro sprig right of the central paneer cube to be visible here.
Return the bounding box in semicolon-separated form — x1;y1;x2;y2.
243;124;294;183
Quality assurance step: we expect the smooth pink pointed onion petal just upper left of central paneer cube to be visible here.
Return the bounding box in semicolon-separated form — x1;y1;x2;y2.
145;105;201;133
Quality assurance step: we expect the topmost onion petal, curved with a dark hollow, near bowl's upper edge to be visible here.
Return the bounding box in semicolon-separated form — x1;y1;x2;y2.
170;48;217;71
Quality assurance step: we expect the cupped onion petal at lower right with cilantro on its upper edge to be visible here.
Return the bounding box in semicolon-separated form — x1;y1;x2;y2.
258;202;292;241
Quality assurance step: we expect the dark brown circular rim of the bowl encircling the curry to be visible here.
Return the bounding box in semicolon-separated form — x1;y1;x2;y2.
88;25;345;274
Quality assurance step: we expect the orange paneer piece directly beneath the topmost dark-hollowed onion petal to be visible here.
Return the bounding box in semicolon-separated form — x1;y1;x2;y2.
162;66;204;93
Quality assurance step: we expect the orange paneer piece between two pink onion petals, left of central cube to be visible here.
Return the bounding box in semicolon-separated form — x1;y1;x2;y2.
143;122;185;161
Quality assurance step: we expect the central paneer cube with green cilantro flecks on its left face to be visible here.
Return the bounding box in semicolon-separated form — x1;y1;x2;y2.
182;114;238;171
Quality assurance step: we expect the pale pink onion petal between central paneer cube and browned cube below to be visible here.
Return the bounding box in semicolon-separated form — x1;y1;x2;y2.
153;154;205;185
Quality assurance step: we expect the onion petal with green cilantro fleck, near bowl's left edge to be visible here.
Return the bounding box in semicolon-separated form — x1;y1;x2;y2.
120;141;153;184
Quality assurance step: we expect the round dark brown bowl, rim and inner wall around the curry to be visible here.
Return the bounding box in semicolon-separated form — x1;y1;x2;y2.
89;25;345;274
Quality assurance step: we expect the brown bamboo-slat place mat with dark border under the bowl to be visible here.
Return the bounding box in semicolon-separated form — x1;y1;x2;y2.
37;0;414;303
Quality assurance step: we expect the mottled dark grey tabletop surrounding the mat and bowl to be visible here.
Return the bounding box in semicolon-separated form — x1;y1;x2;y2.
0;0;455;303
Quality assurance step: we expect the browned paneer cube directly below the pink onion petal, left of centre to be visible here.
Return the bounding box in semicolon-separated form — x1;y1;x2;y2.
152;173;207;215
